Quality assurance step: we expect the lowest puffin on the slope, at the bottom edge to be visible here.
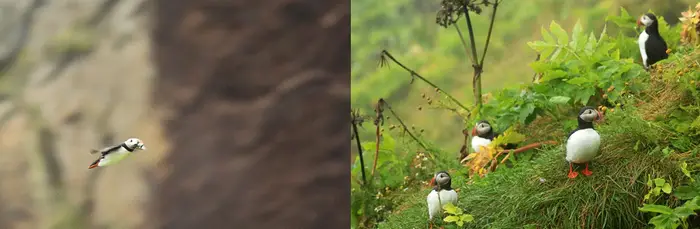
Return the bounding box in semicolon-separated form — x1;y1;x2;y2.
427;171;457;228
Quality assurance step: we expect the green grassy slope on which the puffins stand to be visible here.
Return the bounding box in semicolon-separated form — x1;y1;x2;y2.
379;51;700;229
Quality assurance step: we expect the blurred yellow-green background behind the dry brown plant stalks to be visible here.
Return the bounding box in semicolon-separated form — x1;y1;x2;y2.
351;0;697;154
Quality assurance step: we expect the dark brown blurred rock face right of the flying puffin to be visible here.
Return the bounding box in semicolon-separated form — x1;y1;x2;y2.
153;0;350;228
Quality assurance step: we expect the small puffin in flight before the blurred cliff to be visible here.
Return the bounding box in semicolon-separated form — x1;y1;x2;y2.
88;138;146;169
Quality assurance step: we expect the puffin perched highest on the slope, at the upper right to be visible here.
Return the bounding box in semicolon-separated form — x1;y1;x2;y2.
637;13;668;69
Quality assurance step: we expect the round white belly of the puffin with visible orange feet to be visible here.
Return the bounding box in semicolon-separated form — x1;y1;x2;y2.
566;128;600;163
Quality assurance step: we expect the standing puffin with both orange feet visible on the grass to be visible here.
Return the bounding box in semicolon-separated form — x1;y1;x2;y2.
566;106;601;179
